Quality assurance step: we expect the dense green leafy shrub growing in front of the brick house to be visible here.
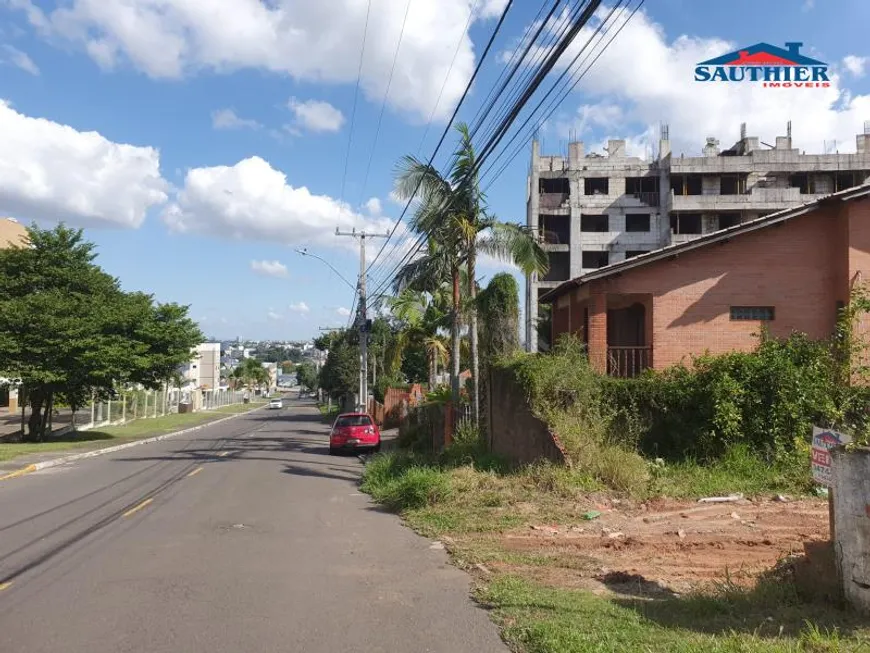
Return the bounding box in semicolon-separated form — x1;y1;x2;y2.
604;334;852;461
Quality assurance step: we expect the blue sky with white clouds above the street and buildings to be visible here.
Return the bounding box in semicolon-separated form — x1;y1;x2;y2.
0;0;870;339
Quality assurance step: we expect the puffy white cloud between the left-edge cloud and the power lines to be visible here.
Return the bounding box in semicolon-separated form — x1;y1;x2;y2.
163;156;392;247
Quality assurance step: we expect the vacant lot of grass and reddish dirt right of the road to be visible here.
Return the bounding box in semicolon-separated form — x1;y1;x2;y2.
363;454;870;653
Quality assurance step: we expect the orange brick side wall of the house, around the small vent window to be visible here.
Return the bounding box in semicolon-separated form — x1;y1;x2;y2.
590;200;870;369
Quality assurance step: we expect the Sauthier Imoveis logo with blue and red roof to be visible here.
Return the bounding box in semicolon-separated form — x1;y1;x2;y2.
695;43;831;88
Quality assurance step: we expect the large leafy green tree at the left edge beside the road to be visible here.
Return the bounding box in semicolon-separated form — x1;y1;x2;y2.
0;225;202;440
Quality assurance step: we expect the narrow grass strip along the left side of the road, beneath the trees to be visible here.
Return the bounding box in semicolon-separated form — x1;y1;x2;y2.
0;403;263;462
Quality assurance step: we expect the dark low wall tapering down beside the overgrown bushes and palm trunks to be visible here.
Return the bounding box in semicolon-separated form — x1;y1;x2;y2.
486;368;568;464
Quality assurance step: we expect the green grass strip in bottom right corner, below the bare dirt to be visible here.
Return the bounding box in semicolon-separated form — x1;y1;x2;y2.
477;576;870;653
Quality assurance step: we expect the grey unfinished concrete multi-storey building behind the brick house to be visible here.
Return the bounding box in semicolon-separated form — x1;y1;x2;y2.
525;122;870;351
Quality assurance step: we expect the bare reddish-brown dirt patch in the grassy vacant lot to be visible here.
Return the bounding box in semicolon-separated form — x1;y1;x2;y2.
466;500;828;595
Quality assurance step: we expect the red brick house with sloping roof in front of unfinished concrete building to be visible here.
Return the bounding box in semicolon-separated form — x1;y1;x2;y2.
542;185;870;376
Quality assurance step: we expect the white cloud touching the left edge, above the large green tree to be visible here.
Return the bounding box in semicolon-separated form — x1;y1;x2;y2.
0;99;169;228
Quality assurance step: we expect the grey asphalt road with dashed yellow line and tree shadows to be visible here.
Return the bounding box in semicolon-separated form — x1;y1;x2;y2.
0;402;506;653
